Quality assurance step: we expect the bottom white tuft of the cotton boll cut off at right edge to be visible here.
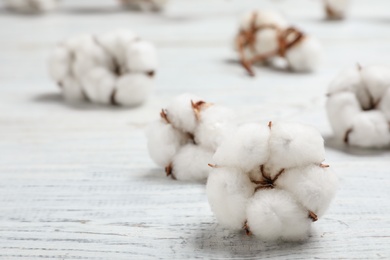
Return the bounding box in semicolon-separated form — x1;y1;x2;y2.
347;111;390;148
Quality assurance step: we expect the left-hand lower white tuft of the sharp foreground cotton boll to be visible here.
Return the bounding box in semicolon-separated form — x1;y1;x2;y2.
206;168;254;230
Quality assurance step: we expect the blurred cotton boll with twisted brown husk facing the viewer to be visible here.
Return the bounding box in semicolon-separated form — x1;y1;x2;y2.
235;10;322;76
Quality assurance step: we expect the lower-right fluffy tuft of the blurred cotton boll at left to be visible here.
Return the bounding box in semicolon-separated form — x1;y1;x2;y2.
113;74;154;106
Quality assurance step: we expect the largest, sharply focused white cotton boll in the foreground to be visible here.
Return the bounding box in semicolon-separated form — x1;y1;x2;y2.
206;122;338;241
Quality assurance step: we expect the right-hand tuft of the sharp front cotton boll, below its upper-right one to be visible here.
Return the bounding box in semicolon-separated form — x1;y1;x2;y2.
275;165;338;217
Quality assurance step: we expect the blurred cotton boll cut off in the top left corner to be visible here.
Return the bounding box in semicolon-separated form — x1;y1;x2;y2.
4;0;59;13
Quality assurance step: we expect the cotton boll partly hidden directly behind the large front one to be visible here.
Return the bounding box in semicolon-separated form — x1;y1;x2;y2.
146;94;235;181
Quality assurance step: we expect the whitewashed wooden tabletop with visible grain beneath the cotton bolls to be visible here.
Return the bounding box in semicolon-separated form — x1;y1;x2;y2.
0;0;390;259
